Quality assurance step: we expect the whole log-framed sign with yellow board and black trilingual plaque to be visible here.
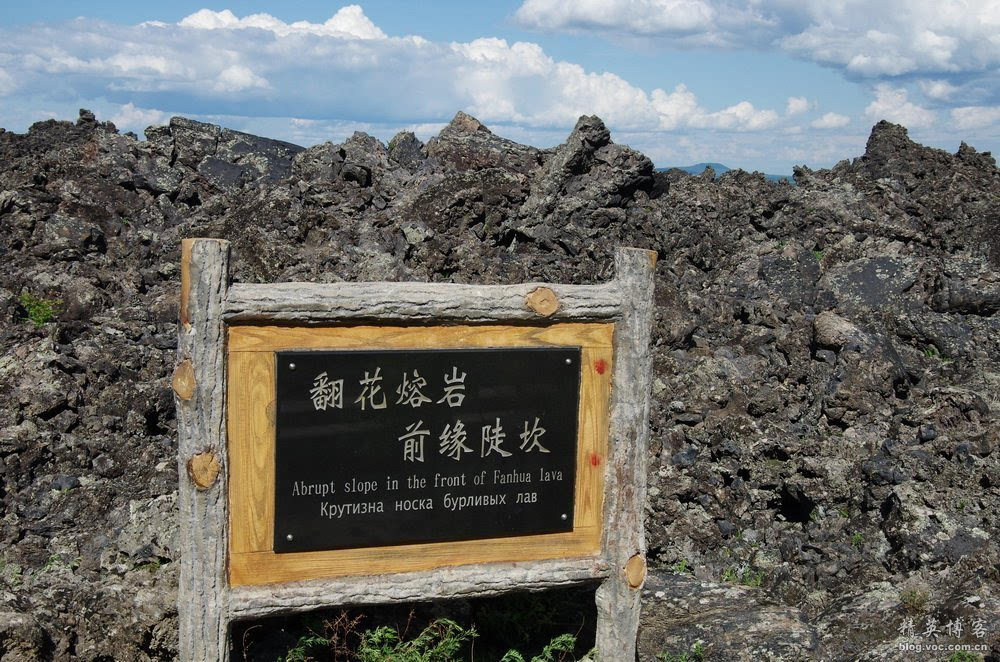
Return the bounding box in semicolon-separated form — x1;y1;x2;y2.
173;239;655;661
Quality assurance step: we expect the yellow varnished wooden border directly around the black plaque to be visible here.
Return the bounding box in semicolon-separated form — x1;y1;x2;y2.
229;323;614;586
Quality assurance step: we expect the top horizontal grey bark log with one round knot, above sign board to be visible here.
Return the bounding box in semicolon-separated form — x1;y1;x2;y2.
225;282;622;324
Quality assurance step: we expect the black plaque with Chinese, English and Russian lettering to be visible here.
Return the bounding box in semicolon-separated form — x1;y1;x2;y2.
274;347;581;553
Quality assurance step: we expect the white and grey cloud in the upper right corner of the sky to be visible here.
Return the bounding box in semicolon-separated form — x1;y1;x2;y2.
515;0;1000;93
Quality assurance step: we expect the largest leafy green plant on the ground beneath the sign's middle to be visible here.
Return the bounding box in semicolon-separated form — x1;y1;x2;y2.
358;618;476;662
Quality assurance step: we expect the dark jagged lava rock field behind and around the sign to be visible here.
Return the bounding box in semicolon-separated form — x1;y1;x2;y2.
0;113;1000;660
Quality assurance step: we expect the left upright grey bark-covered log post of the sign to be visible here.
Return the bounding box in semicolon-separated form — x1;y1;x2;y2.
175;239;229;662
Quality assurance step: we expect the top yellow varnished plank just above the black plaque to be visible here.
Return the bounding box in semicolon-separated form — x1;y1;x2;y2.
229;322;614;353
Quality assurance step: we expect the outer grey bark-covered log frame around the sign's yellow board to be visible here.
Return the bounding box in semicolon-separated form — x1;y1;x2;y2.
173;239;656;661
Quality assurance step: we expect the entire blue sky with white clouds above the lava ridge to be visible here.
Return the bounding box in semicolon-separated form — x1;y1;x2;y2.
0;0;1000;174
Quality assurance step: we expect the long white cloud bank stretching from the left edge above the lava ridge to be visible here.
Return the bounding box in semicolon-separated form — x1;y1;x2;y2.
0;7;779;132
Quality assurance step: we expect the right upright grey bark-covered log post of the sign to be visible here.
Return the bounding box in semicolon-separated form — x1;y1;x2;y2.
596;248;656;661
